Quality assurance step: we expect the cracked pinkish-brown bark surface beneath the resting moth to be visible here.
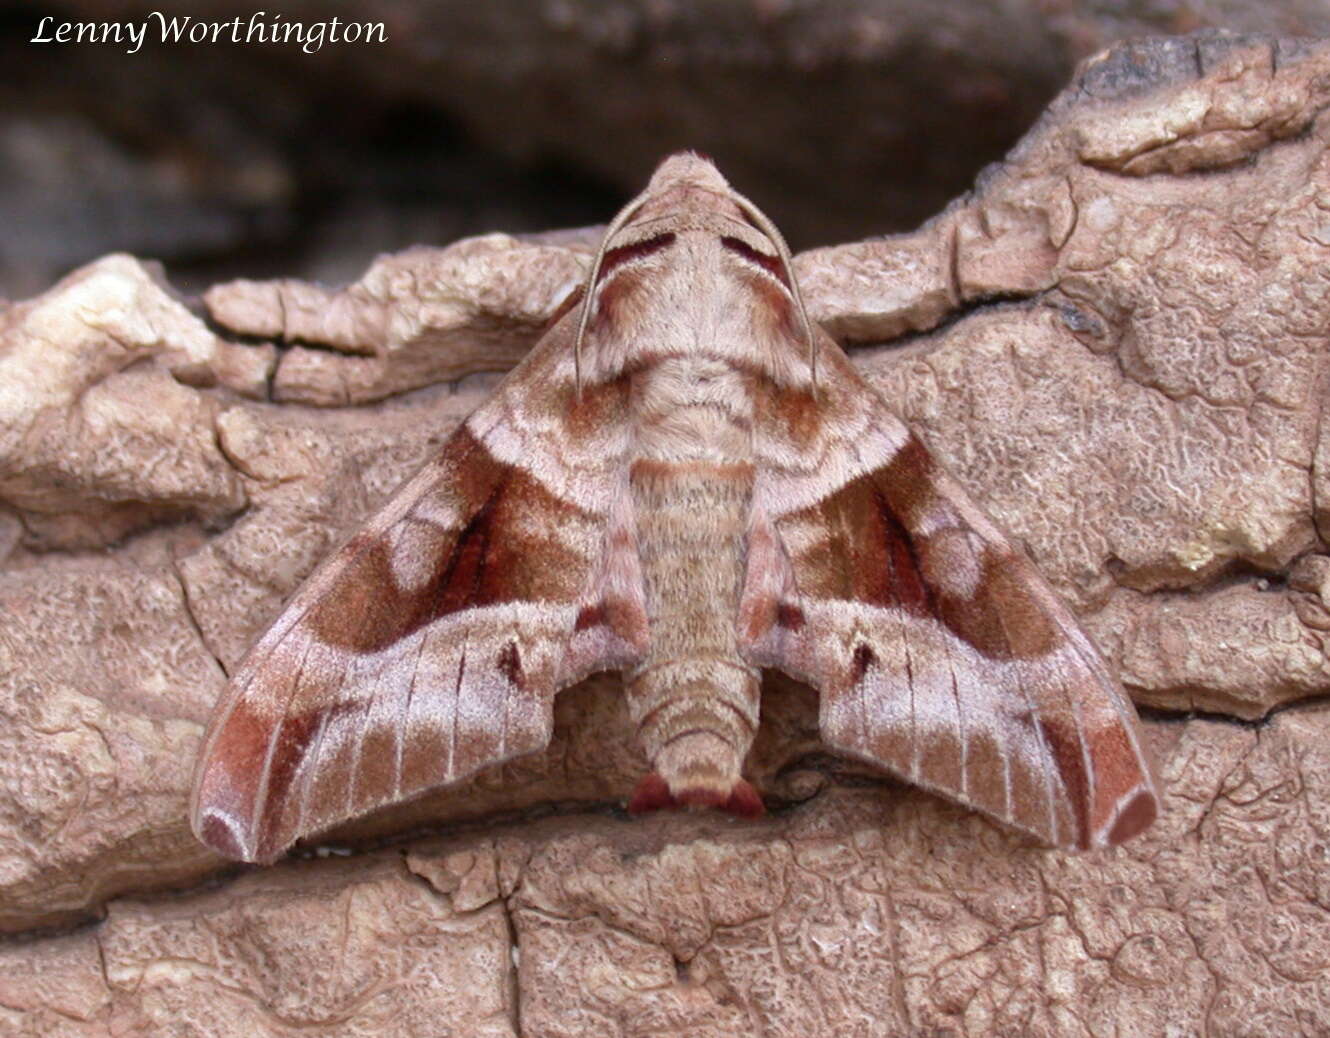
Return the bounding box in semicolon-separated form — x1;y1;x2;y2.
0;36;1330;1035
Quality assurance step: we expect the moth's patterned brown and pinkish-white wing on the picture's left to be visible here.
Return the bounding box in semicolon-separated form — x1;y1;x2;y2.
192;322;645;861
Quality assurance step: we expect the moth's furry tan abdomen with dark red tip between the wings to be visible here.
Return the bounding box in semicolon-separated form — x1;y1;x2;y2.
626;459;761;814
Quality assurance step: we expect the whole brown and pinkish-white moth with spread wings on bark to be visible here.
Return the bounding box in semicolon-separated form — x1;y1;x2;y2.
192;154;1157;861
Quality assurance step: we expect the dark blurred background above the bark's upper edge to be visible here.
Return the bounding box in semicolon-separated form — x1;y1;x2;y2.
0;0;1330;298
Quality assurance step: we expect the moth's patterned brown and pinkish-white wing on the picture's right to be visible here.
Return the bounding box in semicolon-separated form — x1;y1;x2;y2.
739;341;1157;846
